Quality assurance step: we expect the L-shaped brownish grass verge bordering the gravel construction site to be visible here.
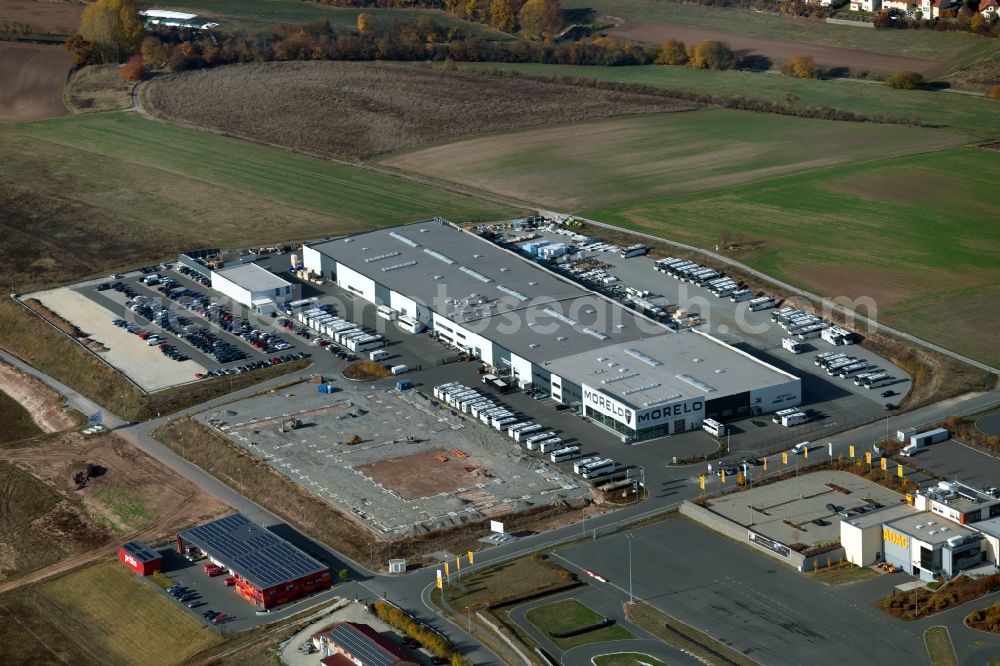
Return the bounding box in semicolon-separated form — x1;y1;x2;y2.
153;418;569;568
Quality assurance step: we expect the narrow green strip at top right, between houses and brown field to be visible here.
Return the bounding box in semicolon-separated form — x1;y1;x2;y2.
563;0;1000;63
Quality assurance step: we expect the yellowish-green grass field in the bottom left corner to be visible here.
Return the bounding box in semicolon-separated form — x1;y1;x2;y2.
0;561;222;666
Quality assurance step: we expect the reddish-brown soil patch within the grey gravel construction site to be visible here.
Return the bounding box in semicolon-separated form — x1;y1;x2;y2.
355;449;490;500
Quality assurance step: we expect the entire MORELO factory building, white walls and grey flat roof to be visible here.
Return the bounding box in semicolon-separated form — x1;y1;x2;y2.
302;220;802;441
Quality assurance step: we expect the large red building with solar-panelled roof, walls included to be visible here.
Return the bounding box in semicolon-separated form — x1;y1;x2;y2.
177;513;333;608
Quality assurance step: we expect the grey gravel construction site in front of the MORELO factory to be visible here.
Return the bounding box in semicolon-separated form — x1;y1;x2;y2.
197;379;588;539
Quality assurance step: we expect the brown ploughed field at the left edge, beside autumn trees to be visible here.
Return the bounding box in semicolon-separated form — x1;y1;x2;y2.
0;43;73;123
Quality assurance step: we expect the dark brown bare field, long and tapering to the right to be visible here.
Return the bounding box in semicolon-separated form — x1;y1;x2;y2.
146;62;693;159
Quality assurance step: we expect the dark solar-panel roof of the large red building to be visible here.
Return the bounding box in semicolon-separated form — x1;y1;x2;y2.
181;513;329;589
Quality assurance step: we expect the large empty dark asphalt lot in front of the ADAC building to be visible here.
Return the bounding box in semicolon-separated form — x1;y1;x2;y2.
556;517;927;666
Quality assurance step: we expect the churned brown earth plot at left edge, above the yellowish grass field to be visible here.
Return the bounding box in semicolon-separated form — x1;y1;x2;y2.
0;433;228;592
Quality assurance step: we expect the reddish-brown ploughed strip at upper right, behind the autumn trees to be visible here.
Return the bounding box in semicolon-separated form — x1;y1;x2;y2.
608;21;952;77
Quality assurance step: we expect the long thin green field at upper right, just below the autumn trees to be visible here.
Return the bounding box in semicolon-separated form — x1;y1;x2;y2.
461;62;1000;139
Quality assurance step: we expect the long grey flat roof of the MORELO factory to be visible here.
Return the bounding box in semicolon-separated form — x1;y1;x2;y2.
311;220;797;396
